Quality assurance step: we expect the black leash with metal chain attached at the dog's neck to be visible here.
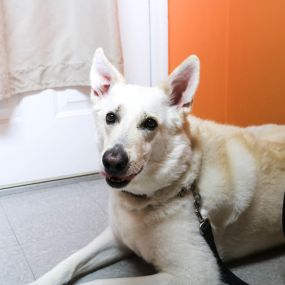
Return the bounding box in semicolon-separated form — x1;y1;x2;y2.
186;183;285;285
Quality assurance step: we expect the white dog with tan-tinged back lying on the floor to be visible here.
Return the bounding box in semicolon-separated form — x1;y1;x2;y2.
29;49;285;285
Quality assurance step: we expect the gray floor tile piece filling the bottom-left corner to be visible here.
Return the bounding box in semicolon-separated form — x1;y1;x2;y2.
0;246;34;285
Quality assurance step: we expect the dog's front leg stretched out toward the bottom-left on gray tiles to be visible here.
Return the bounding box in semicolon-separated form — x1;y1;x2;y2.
30;227;130;285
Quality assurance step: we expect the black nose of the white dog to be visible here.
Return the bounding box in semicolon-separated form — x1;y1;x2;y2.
102;144;129;175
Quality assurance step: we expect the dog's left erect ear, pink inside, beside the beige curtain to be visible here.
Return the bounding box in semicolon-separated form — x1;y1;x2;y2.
90;48;124;96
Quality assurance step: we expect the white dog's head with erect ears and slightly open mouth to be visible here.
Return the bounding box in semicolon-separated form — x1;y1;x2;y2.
90;49;199;195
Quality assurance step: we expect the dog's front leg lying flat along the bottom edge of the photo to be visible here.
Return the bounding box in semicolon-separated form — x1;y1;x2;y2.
79;272;175;285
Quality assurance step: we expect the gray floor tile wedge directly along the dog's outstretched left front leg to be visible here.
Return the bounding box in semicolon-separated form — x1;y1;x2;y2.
23;229;105;278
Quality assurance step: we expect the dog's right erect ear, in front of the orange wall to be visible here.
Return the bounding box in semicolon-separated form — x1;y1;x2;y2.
168;55;200;107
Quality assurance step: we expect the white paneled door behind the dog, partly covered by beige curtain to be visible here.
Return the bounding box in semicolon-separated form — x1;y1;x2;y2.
0;0;168;189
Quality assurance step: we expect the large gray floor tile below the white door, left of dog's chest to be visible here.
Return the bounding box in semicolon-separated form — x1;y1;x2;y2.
1;184;107;245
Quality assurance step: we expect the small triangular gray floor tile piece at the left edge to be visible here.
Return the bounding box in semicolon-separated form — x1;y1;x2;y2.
0;203;18;249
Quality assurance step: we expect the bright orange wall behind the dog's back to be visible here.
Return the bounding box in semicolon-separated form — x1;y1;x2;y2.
169;0;285;125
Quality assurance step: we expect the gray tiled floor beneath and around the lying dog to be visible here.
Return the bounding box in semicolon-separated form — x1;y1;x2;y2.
0;178;285;285
